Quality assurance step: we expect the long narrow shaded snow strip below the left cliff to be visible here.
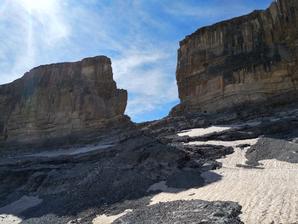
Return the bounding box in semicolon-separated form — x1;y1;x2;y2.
28;144;113;157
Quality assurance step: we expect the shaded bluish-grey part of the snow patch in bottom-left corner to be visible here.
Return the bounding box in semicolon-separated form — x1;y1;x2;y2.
0;195;42;214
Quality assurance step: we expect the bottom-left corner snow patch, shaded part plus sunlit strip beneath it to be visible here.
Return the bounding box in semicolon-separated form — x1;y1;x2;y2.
0;196;42;224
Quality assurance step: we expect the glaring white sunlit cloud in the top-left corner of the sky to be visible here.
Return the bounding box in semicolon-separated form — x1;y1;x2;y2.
0;0;70;83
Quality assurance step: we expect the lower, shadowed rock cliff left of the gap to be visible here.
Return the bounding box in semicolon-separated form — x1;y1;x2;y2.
0;56;127;145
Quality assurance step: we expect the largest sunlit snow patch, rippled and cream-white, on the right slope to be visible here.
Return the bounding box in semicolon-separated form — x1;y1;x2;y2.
151;139;298;224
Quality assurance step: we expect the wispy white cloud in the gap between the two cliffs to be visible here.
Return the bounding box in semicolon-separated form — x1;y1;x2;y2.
113;49;177;119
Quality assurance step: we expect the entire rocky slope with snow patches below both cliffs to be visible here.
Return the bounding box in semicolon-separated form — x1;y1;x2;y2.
0;104;298;224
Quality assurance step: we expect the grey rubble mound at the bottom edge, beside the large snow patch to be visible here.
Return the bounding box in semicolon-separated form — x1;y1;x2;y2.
112;200;243;224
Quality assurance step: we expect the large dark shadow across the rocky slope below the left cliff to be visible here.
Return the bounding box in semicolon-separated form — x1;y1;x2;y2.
0;129;225;223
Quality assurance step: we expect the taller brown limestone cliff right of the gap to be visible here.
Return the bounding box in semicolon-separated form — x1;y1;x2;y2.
172;0;298;113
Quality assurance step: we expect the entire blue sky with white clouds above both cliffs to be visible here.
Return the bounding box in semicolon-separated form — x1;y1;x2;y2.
0;0;271;122
